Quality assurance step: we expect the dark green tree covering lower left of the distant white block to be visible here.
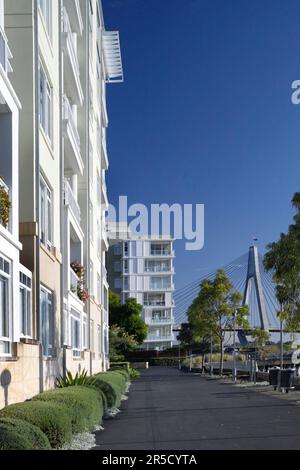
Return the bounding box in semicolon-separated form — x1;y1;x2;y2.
109;291;148;345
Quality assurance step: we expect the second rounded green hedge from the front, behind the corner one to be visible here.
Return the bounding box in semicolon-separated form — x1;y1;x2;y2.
0;401;72;448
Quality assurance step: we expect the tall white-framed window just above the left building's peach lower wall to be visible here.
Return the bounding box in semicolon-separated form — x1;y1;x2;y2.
40;176;52;250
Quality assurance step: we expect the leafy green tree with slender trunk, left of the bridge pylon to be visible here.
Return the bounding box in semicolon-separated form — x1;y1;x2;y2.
188;269;249;375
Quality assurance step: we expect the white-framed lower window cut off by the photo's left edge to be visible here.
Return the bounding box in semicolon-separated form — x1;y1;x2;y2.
0;256;11;355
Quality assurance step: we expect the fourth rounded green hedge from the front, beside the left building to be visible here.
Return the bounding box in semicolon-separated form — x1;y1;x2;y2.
86;371;127;408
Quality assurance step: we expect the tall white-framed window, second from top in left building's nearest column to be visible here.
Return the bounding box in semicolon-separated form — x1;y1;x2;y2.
39;65;52;141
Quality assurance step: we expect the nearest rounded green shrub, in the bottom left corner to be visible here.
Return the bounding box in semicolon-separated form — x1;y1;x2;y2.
0;418;51;450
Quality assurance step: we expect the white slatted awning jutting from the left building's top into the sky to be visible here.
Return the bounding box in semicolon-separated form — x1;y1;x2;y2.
103;31;124;83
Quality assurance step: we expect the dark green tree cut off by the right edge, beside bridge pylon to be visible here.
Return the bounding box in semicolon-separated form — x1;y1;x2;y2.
264;192;300;331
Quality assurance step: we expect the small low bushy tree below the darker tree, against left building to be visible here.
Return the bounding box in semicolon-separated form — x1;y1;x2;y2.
109;325;137;361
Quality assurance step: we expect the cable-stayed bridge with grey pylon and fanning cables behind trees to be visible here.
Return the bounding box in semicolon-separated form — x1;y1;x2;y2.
174;246;280;334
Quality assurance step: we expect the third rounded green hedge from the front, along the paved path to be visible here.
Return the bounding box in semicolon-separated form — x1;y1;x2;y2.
33;386;104;433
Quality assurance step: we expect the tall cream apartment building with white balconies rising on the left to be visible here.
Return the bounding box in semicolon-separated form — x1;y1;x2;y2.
0;0;123;407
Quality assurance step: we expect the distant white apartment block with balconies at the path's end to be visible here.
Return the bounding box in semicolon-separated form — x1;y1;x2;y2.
107;231;175;350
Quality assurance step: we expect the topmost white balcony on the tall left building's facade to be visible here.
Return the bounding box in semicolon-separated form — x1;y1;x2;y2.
62;8;83;106
